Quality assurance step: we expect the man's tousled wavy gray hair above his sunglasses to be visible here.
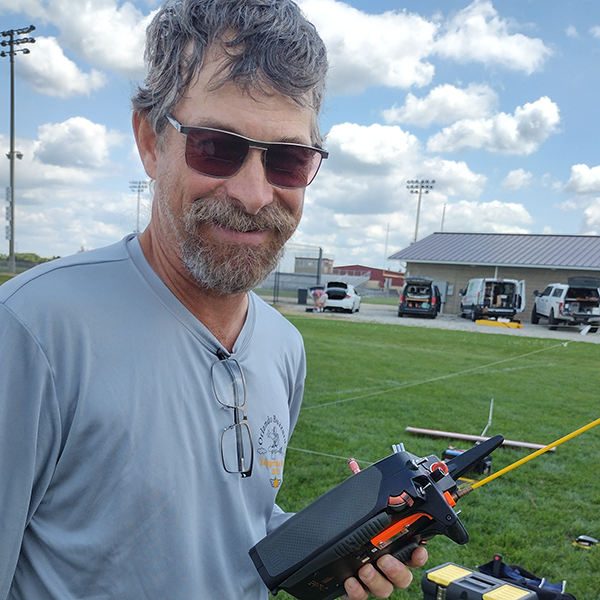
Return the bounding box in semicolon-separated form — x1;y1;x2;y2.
132;0;328;146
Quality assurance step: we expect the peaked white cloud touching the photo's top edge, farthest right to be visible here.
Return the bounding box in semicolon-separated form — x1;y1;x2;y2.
436;0;552;75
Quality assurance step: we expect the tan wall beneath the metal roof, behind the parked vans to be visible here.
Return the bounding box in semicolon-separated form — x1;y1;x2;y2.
406;262;600;320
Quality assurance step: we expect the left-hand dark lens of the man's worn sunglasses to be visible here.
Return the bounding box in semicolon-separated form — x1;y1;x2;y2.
185;129;249;177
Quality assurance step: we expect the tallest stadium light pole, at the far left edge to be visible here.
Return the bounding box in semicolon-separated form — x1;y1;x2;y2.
0;25;35;273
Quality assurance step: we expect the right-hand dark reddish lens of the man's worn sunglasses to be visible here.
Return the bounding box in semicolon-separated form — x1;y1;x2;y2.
265;144;322;188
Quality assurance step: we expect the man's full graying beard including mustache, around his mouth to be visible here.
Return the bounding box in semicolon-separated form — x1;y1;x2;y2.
179;198;298;294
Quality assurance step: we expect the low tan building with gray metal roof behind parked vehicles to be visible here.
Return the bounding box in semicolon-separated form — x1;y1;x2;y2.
389;232;600;317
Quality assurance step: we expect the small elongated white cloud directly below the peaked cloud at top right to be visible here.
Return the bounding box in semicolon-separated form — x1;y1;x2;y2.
383;84;498;127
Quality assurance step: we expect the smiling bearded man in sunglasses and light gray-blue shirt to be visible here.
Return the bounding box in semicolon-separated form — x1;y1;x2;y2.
0;0;425;600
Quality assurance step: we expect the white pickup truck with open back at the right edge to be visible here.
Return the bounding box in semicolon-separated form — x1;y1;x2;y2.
531;277;600;333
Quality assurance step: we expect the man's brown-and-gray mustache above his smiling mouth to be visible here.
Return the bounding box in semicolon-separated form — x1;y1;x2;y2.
186;198;298;235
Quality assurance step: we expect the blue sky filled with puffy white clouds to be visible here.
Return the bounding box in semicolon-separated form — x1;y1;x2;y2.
0;0;600;269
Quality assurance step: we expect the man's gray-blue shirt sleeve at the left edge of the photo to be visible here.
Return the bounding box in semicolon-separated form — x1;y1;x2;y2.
0;305;60;600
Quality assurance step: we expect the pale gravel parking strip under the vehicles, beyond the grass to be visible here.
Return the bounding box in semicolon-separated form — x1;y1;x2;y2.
274;298;600;344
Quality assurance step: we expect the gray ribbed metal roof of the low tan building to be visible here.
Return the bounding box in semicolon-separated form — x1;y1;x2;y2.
390;232;600;269
